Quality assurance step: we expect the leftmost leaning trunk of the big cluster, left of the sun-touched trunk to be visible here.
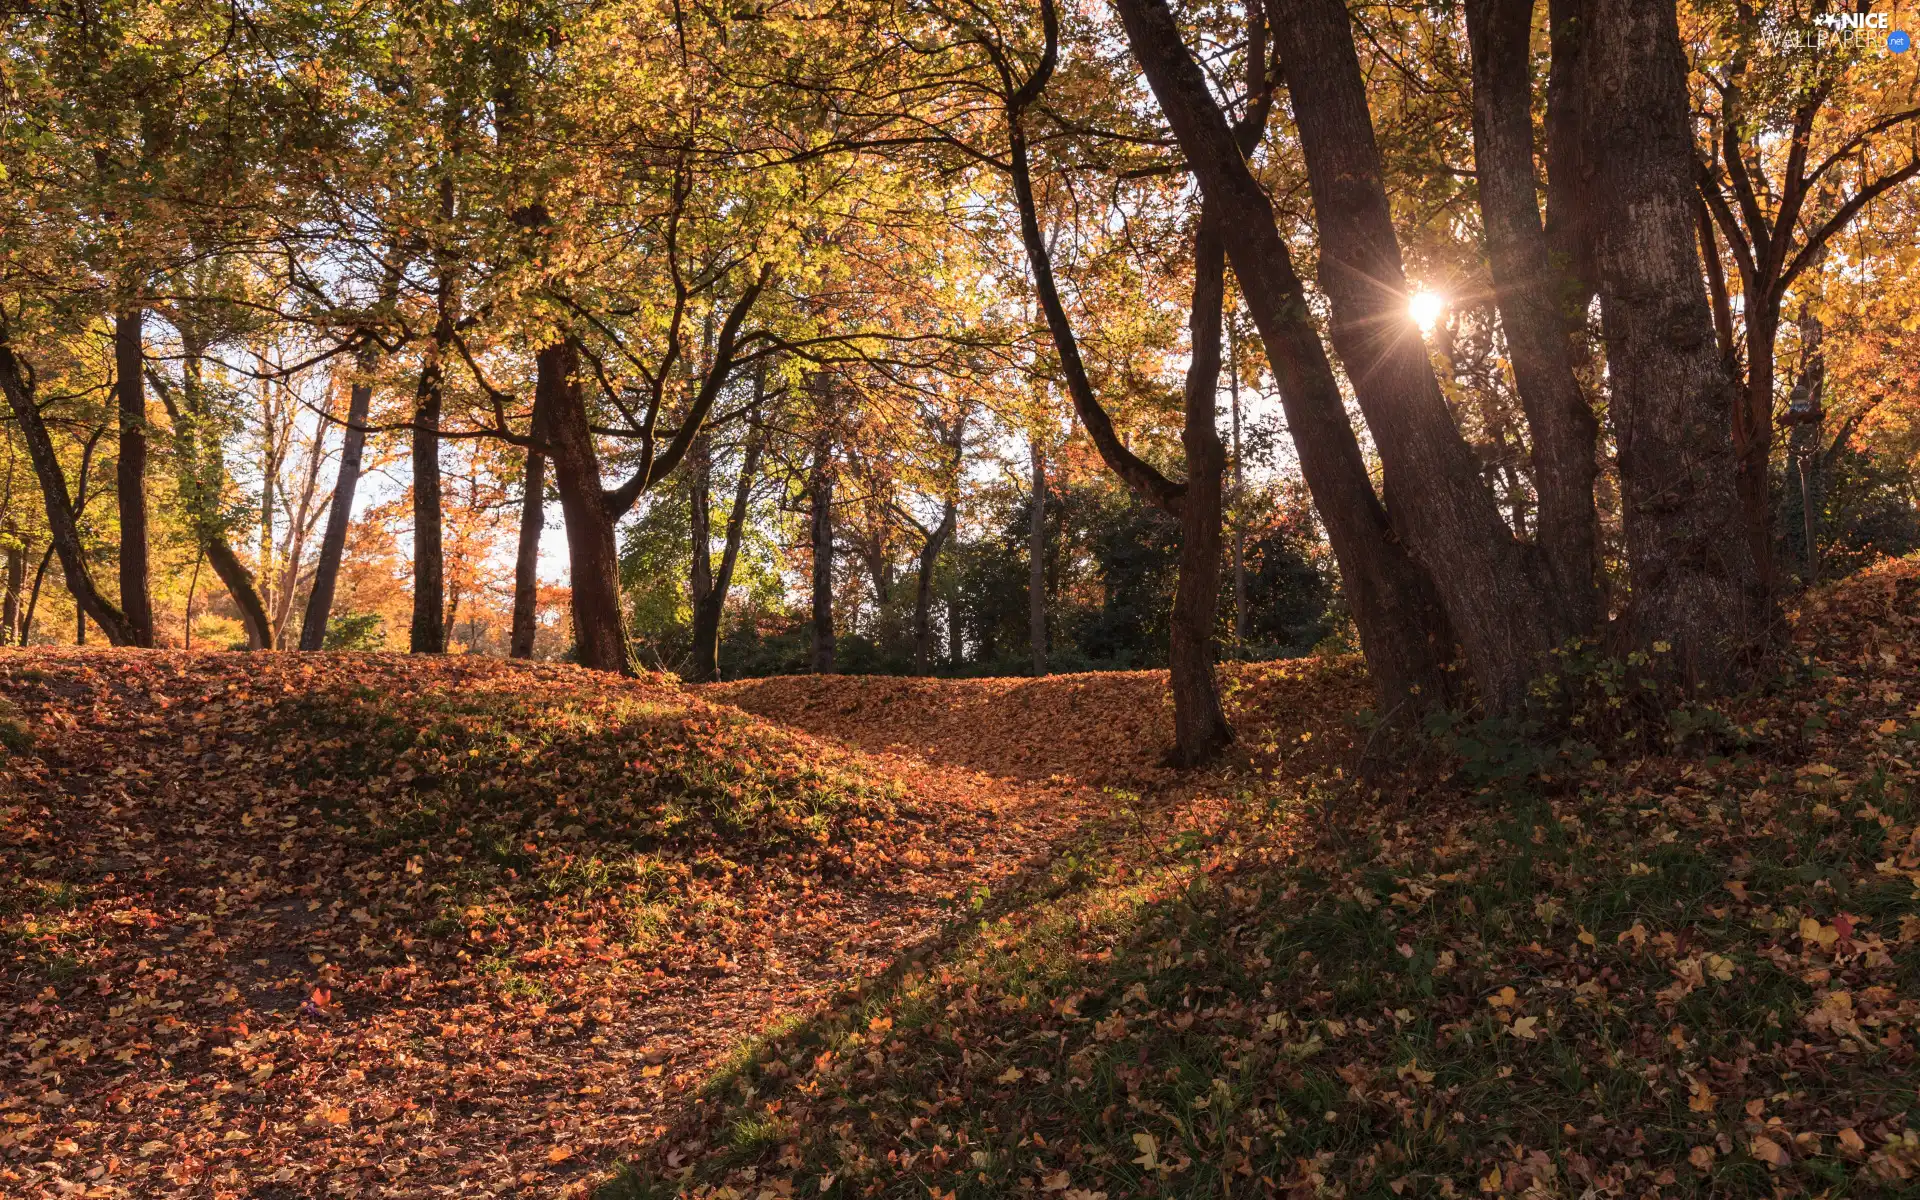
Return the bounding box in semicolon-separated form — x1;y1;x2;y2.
1116;0;1452;722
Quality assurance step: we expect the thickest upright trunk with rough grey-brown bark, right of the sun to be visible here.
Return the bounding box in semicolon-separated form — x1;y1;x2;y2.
1582;0;1766;687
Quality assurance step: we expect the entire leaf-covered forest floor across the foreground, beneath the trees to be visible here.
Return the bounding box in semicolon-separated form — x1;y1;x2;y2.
0;561;1920;1200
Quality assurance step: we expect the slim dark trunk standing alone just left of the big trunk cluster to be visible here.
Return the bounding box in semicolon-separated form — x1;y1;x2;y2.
1167;211;1233;766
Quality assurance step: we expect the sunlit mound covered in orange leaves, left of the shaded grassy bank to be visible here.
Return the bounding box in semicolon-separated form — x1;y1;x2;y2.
0;651;1085;1198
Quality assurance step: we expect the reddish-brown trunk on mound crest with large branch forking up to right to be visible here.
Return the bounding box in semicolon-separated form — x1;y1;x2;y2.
534;340;634;676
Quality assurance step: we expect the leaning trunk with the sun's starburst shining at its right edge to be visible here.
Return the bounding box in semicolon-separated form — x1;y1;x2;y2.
1275;0;1555;712
